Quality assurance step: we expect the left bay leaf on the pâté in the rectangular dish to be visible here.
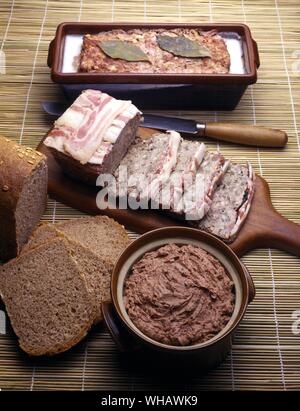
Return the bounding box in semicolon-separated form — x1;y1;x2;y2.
99;40;149;61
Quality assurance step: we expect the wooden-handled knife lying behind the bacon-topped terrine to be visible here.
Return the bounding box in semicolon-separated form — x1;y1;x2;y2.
42;101;288;147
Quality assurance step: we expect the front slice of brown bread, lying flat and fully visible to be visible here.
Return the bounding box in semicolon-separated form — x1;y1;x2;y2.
0;238;95;355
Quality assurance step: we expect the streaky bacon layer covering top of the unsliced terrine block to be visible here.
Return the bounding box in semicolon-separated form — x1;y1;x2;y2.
44;90;140;164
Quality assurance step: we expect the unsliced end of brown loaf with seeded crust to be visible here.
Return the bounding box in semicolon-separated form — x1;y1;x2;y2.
0;136;48;260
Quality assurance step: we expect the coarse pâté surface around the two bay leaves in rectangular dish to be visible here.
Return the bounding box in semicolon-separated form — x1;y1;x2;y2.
79;28;230;74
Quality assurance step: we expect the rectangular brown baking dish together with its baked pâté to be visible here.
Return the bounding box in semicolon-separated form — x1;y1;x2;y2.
47;22;260;110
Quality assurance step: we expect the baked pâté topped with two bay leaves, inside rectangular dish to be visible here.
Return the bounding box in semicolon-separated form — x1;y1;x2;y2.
79;28;230;74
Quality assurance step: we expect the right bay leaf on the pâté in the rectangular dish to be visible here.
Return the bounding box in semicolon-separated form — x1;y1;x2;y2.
156;35;211;57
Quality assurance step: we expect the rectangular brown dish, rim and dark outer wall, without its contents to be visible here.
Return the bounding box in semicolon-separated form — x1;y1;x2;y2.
48;23;259;110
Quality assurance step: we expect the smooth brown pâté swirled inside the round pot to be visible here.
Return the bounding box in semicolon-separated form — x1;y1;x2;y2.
124;244;235;346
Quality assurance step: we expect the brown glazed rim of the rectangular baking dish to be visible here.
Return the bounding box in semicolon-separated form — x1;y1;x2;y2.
48;22;260;85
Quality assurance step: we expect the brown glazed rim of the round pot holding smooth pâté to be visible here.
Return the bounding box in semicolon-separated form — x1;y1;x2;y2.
111;226;255;352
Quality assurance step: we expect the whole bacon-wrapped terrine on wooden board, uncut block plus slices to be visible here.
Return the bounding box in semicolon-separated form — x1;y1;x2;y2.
44;90;254;242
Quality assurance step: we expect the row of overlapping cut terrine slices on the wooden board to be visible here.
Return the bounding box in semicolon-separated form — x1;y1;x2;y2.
113;131;254;242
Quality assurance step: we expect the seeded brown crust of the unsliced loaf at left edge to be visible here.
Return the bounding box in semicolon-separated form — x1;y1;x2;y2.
0;136;47;260
